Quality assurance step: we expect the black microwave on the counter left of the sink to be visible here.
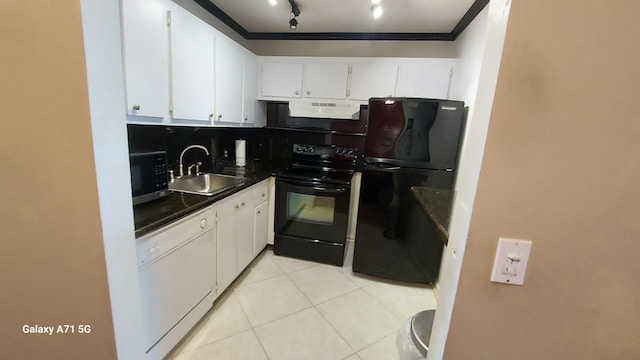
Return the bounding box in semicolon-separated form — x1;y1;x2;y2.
129;151;169;205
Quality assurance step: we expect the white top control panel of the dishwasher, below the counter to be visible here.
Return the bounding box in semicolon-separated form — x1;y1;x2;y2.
137;207;215;266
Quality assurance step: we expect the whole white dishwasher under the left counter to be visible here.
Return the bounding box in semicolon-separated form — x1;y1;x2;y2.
138;208;216;359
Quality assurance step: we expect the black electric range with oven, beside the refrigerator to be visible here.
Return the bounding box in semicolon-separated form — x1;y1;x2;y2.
274;144;358;266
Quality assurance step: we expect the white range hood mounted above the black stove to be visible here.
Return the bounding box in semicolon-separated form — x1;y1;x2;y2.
289;100;360;120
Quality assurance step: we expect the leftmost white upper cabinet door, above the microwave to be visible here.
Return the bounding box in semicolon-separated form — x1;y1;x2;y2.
122;0;169;118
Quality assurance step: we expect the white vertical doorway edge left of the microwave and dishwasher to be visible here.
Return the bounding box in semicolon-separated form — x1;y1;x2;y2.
81;0;144;360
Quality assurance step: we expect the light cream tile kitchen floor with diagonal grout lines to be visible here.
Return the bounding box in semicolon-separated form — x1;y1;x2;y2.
166;243;436;360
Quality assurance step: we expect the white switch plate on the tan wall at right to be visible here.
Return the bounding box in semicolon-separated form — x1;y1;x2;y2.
491;238;531;285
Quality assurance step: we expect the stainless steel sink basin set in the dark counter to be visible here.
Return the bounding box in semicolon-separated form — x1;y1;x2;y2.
169;173;245;196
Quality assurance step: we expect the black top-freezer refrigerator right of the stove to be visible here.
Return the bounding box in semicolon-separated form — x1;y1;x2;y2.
353;98;464;283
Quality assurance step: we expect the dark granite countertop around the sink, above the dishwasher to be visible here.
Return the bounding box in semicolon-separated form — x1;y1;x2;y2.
133;172;271;238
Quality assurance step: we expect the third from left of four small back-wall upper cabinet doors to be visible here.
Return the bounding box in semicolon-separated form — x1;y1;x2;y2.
349;64;398;100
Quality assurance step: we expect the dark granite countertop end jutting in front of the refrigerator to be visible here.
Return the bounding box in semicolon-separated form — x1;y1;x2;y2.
411;186;453;245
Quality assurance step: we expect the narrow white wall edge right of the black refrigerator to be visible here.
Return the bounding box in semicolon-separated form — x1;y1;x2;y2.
427;0;511;360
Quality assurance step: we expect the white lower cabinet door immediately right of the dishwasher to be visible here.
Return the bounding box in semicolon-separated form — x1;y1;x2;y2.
216;196;238;294
